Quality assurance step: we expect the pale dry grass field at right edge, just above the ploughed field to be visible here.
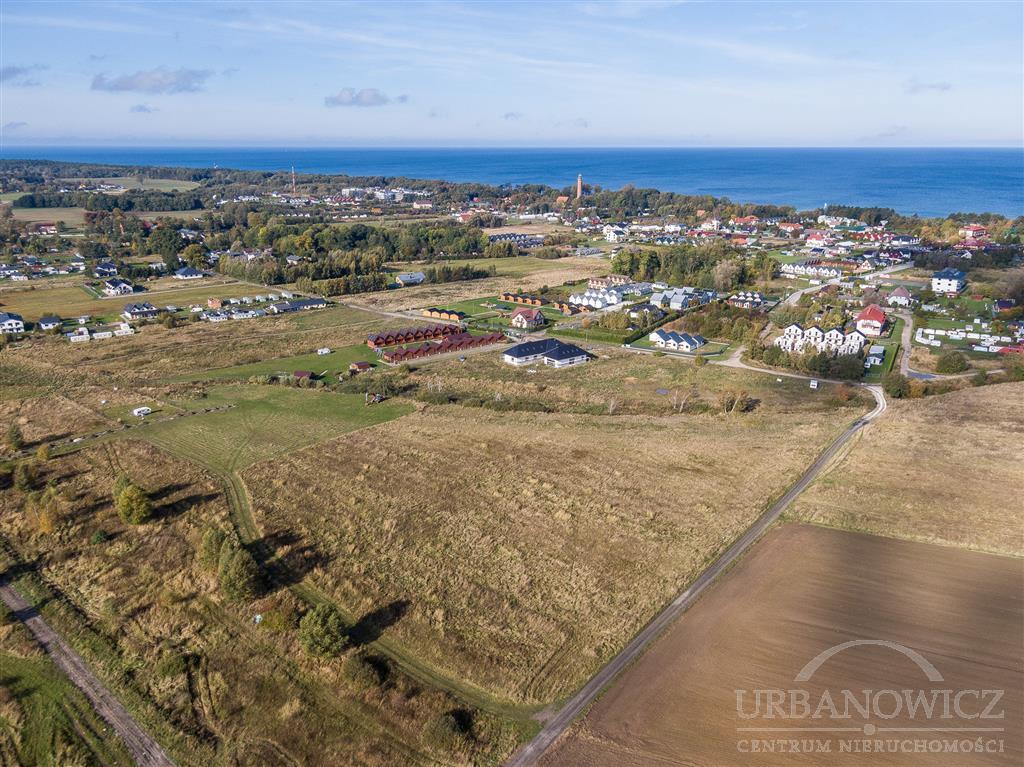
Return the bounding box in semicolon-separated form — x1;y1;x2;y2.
792;383;1024;556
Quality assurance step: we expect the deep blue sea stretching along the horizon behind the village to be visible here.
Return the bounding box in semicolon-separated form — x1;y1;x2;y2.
0;146;1024;216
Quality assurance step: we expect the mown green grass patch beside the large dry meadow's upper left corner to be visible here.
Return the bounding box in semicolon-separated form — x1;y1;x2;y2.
131;385;413;474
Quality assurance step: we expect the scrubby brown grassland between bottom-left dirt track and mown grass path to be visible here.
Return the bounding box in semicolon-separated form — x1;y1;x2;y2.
0;440;517;767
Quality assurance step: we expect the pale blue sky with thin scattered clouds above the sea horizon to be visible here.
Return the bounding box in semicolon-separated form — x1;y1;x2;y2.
0;0;1024;146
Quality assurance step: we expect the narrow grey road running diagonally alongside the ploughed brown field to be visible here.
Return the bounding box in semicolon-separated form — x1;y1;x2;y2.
505;386;886;767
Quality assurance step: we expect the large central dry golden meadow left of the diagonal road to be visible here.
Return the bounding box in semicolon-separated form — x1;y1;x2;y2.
243;397;861;704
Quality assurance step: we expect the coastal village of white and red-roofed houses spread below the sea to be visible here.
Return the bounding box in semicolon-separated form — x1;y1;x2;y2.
0;177;1024;389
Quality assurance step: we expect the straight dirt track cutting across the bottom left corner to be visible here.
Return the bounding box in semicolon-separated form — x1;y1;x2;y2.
0;580;174;767
